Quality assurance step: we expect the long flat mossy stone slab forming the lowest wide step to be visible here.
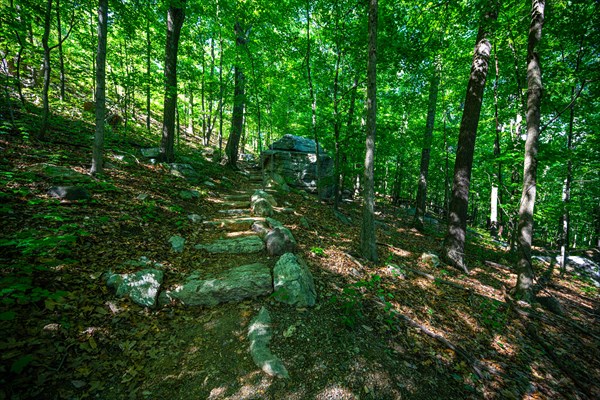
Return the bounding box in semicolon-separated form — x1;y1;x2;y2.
166;264;273;306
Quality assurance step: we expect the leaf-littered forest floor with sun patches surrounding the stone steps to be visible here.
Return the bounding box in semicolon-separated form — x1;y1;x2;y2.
0;104;600;400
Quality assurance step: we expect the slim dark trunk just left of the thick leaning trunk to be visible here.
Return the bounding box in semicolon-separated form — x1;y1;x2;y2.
413;61;440;231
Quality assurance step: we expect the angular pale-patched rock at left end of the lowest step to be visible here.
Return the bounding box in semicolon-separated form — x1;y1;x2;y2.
106;269;163;307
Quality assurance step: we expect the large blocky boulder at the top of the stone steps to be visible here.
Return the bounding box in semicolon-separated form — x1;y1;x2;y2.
261;135;334;198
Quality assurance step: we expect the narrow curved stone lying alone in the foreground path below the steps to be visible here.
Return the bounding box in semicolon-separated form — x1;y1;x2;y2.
248;307;289;378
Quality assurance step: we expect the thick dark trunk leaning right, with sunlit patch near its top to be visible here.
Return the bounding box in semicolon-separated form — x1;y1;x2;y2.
443;9;497;273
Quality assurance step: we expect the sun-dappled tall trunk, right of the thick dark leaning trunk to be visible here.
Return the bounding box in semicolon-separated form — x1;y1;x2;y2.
515;0;545;301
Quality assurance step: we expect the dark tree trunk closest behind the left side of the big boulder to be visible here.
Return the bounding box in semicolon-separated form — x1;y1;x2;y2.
225;22;246;168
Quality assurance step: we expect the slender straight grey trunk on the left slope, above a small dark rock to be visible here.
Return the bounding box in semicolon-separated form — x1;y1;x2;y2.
90;0;108;175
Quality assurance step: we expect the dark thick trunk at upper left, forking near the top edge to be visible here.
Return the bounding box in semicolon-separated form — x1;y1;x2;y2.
160;0;185;162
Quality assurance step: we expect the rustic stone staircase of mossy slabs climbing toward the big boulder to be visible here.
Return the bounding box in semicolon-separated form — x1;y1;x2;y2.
109;164;316;378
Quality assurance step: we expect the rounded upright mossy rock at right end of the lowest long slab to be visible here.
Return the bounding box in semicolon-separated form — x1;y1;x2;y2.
273;253;317;307
